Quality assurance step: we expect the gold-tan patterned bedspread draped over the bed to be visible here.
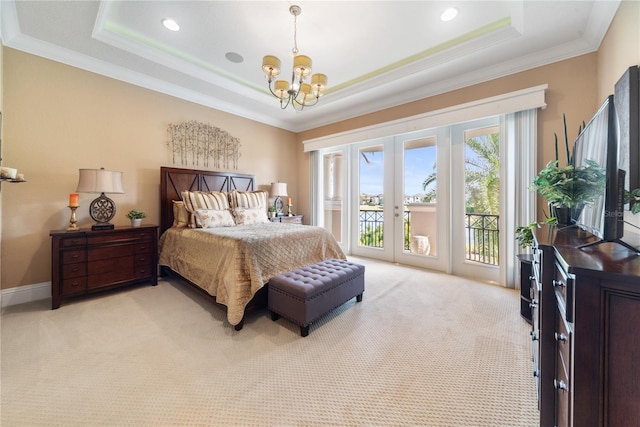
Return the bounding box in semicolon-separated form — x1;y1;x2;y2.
158;223;346;325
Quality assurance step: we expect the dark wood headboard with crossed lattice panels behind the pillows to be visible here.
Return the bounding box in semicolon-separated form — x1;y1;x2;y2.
160;166;256;234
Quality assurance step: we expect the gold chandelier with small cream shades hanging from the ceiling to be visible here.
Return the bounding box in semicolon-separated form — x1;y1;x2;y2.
262;5;327;111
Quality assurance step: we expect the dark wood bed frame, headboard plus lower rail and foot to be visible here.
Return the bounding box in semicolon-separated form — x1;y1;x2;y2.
160;166;267;331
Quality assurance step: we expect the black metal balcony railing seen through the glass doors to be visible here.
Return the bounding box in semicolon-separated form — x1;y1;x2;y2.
359;210;500;265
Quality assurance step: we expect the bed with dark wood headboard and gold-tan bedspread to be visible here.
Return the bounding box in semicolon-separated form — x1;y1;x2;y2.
158;167;346;330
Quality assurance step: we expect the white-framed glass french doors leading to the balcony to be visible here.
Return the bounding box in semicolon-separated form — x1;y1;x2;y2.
348;118;500;281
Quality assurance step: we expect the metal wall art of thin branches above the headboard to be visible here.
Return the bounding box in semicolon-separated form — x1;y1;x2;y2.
167;120;240;170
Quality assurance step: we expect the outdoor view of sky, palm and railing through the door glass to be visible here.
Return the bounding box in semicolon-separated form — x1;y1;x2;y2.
359;128;500;265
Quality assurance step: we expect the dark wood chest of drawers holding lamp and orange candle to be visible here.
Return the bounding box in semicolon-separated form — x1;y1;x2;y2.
50;225;158;309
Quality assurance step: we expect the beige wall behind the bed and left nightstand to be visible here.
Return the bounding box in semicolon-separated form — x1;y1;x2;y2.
1;48;298;289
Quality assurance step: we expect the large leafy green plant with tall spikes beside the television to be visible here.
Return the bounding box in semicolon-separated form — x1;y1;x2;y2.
532;115;606;225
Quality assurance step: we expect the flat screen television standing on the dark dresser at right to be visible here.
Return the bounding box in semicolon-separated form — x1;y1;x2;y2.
573;95;637;252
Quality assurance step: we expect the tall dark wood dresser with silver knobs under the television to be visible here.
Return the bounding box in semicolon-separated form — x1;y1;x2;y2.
533;226;640;427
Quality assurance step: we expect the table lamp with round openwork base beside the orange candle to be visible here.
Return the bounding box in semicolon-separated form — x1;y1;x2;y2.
76;168;124;230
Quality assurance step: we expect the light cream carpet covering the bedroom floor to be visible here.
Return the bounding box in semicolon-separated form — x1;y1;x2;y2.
0;258;538;427
